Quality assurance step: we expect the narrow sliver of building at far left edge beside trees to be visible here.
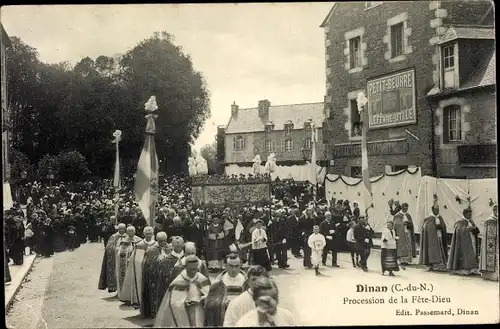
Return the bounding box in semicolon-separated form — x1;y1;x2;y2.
0;24;10;182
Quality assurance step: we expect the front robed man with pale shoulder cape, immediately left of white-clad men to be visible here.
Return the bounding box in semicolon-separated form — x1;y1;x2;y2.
205;254;248;327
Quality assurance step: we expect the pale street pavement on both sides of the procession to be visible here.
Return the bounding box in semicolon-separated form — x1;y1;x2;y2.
6;243;499;329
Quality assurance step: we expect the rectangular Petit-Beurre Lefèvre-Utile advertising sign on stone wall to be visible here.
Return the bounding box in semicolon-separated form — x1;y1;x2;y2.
366;69;417;129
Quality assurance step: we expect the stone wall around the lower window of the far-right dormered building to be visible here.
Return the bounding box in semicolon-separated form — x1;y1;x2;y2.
435;87;497;179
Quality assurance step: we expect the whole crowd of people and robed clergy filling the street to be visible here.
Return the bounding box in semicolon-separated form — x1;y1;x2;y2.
4;175;498;327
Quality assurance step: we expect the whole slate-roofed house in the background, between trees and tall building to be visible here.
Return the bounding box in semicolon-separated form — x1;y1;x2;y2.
224;100;325;166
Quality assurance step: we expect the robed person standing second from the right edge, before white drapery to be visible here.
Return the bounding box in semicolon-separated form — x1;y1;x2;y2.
447;208;479;275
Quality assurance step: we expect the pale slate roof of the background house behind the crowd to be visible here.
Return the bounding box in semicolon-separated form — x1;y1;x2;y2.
226;102;324;134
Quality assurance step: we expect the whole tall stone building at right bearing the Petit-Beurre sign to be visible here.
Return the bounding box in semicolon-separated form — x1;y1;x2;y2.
321;1;496;178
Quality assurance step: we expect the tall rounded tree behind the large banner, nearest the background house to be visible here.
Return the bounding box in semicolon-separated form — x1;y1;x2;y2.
120;32;210;172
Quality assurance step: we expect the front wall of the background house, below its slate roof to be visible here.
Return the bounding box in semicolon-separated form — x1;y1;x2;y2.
225;128;325;163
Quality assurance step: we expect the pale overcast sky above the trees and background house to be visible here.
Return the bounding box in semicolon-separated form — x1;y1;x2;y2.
1;2;332;149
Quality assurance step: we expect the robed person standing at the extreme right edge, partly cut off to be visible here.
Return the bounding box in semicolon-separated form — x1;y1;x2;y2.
479;204;499;281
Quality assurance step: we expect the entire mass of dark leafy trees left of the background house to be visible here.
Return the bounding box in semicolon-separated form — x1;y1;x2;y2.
7;32;210;179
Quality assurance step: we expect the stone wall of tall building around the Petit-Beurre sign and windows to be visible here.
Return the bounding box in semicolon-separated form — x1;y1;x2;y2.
324;1;436;175
